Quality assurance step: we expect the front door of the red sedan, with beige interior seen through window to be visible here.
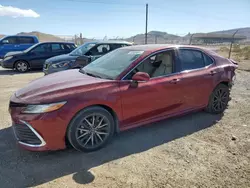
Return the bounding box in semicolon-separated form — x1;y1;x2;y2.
120;50;183;126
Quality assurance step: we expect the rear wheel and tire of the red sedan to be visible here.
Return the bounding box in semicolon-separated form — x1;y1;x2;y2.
205;84;230;114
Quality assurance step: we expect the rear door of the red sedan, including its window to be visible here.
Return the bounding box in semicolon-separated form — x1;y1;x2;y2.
178;48;216;109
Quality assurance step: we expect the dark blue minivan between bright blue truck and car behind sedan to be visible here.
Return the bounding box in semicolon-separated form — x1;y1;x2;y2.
1;42;76;72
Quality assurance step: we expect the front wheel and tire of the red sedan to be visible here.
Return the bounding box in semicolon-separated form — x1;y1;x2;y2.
67;107;115;152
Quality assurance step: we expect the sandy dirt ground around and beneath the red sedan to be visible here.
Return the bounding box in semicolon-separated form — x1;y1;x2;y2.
0;62;250;188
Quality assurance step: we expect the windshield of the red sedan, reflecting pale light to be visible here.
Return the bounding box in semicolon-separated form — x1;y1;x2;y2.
81;48;144;79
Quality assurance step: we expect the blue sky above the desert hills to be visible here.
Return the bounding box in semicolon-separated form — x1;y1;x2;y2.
0;0;250;38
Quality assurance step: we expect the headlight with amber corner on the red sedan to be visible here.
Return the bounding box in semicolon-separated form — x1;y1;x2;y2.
22;101;66;114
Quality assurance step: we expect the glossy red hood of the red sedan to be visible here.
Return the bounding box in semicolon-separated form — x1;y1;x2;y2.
15;69;110;104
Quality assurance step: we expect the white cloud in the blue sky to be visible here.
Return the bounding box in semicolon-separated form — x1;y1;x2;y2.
0;5;40;18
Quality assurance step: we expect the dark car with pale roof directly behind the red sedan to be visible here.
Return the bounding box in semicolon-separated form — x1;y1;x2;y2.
43;41;131;75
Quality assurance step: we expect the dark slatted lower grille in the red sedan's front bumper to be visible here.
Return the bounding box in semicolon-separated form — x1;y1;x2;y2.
13;124;41;145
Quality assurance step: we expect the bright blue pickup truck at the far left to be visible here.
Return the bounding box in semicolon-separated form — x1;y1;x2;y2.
0;35;39;59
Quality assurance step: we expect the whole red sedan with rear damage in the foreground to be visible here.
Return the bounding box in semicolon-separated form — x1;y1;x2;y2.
9;45;237;151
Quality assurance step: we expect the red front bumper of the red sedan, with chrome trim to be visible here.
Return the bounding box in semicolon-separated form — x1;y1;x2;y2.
9;96;71;151
